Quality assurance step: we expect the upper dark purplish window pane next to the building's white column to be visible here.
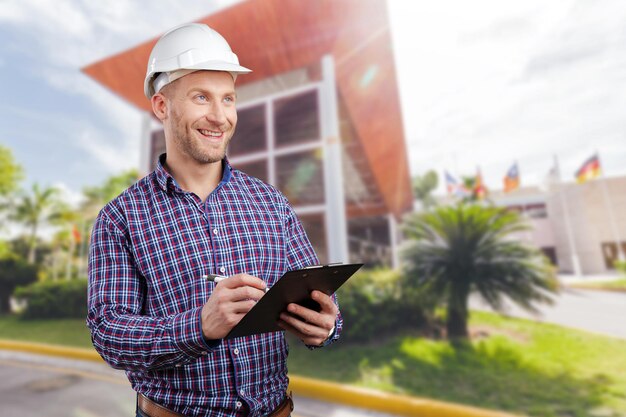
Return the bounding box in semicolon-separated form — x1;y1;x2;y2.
274;90;320;147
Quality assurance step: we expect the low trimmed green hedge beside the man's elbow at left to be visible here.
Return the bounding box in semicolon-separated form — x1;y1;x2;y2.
14;279;87;319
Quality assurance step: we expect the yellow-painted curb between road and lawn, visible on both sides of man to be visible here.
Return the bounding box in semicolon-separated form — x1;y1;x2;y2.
0;339;519;417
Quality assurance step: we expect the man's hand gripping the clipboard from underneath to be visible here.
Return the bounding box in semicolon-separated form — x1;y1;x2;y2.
278;291;338;346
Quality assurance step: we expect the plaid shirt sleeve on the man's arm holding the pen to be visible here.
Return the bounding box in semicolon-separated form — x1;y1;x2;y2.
87;211;219;370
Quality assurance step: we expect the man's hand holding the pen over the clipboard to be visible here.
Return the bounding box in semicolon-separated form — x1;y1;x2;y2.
201;274;265;340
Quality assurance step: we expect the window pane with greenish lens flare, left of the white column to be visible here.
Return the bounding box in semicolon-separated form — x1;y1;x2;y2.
276;149;324;206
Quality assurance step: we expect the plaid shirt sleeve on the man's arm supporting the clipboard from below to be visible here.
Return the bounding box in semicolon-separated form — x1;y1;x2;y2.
283;197;343;349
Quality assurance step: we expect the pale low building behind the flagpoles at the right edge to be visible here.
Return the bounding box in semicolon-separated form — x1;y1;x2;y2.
490;177;626;274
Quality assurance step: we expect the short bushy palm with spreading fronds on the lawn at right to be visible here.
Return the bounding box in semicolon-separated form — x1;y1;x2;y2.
404;203;557;339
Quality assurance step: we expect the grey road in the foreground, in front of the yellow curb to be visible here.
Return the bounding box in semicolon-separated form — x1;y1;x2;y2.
0;350;391;417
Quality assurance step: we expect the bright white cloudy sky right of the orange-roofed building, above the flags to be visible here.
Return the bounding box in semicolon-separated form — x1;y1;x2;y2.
390;0;626;194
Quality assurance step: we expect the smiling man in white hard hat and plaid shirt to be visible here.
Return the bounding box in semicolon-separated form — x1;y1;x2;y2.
87;24;342;417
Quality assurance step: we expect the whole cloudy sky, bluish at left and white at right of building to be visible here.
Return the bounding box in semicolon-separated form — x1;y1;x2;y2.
0;0;626;200
